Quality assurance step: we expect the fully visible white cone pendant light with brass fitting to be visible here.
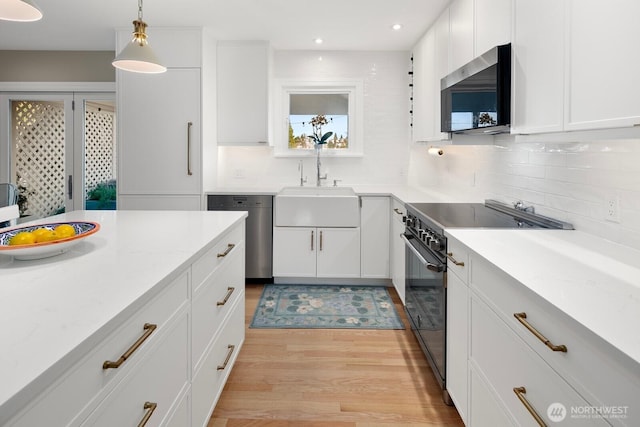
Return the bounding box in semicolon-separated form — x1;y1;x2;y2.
112;0;167;74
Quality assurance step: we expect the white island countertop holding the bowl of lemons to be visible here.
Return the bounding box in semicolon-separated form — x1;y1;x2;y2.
0;211;246;418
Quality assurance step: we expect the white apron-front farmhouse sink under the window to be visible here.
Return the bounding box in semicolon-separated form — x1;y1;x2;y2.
274;187;360;227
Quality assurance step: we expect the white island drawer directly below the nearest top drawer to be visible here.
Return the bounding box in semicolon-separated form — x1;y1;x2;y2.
82;310;189;427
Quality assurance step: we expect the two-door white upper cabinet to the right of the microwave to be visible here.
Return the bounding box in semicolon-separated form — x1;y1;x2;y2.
512;0;640;133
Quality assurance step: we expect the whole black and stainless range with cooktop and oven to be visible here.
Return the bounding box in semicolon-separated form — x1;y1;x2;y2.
402;200;573;405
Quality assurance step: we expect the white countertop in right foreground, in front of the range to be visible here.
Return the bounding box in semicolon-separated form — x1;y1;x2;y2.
445;229;640;363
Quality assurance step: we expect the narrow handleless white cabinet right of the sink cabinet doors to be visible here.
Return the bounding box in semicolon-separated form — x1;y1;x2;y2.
360;196;390;279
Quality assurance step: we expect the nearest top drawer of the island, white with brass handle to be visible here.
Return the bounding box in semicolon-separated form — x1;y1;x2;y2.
8;273;189;427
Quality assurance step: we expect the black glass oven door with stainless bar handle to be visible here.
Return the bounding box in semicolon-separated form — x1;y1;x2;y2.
402;234;447;389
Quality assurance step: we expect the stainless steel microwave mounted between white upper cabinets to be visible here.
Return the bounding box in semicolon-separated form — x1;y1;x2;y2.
440;44;511;134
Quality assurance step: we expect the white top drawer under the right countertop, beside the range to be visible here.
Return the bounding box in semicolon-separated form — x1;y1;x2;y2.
471;257;640;426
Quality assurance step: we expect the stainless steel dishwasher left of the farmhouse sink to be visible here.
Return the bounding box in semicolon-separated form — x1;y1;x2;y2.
207;194;273;282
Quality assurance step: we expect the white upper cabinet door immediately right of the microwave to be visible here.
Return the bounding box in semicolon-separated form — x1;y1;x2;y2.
512;0;564;133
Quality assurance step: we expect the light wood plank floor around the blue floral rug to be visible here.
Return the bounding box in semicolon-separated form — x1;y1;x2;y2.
208;285;463;427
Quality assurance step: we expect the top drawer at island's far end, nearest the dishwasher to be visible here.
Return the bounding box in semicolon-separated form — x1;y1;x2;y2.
191;226;244;293
